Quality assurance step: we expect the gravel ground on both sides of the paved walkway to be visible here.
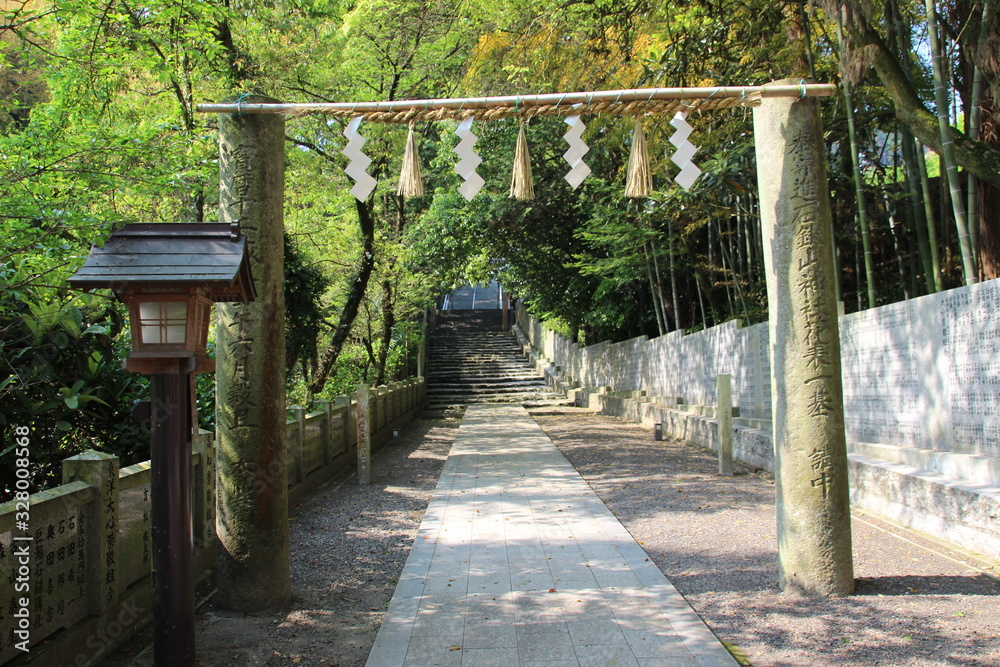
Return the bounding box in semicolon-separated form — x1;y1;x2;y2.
104;407;1000;667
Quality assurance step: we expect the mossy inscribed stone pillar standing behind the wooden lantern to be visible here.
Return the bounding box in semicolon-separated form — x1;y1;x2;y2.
215;96;291;612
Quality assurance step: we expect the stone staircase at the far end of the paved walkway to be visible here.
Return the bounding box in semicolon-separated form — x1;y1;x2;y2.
427;310;566;411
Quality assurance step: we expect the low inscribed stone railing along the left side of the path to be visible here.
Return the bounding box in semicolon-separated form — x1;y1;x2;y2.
0;378;425;667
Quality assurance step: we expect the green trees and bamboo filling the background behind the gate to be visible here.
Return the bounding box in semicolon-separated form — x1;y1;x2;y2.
0;0;1000;490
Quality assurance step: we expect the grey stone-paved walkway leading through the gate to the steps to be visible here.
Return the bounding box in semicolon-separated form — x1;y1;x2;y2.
367;405;737;667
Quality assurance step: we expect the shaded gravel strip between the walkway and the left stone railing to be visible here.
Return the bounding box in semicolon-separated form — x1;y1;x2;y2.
111;417;461;667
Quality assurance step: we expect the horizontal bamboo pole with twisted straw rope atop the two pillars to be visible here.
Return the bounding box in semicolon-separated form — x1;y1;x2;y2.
195;83;837;122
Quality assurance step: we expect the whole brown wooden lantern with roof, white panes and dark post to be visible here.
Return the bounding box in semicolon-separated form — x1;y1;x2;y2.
69;223;255;667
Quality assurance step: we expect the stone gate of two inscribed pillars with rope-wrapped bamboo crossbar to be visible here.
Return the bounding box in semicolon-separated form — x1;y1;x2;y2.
197;80;854;611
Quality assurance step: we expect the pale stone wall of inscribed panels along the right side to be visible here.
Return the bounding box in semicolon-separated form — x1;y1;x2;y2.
519;280;1000;457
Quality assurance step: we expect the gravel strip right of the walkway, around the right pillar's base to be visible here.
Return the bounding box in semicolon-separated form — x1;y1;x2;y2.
533;408;1000;667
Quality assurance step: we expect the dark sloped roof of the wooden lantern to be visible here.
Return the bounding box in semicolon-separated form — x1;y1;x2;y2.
68;222;257;301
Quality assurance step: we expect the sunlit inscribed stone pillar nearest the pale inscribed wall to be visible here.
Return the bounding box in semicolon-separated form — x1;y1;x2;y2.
753;81;854;597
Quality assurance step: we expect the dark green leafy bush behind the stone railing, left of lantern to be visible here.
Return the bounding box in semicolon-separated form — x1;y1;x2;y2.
0;272;149;500
